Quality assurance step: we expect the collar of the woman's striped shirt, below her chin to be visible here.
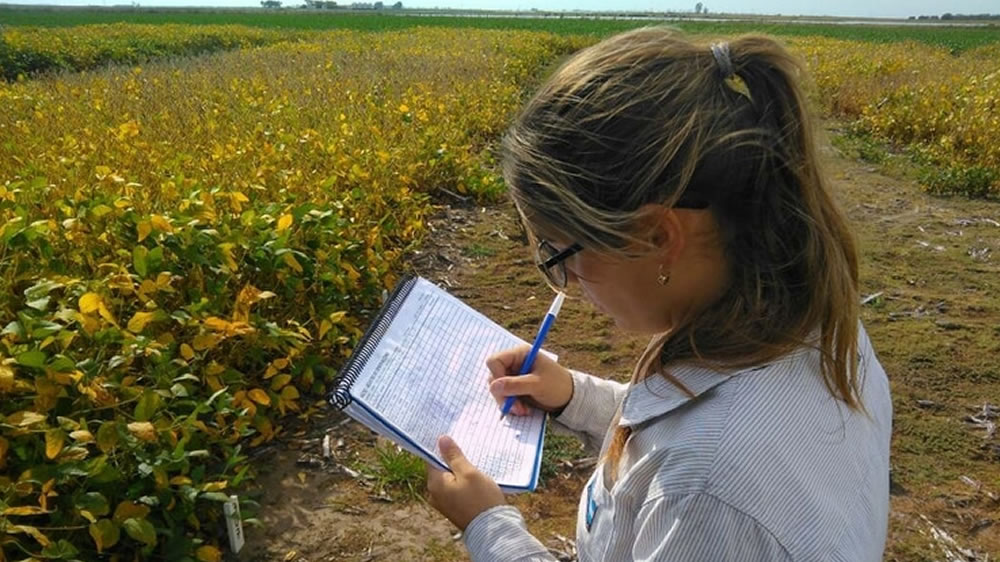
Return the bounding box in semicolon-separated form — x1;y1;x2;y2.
618;365;742;426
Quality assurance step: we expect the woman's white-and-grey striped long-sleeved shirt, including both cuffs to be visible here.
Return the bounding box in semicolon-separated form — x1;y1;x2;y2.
464;328;892;562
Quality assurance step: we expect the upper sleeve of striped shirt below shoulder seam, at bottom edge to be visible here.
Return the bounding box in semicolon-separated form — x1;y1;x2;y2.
632;493;792;562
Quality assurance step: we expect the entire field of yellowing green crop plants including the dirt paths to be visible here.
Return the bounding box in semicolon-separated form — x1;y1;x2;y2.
0;10;1000;561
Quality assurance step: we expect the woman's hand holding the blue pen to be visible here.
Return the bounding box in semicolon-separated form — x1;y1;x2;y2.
486;345;573;416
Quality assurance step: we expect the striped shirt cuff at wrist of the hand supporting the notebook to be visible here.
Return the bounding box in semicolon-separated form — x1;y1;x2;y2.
462;505;556;562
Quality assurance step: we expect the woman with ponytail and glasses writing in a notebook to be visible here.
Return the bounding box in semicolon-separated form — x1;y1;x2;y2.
428;28;892;562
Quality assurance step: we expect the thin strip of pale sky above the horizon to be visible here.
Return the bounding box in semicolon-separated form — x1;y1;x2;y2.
7;0;1000;18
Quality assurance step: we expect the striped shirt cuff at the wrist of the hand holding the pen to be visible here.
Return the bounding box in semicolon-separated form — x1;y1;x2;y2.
553;370;628;454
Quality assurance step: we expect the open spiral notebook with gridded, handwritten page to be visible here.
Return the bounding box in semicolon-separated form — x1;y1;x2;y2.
329;277;545;493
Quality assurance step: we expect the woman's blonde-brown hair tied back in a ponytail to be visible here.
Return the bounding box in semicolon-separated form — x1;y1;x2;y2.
502;27;863;479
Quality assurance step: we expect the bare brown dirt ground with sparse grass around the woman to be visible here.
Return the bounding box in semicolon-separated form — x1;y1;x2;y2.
239;127;1000;562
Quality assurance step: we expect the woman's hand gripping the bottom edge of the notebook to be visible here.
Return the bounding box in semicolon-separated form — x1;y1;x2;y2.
427;436;507;531
